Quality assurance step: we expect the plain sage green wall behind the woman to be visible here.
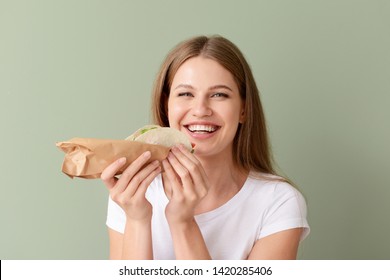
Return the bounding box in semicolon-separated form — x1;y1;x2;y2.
0;0;390;259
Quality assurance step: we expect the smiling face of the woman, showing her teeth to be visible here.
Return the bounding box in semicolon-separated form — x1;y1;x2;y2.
168;56;243;159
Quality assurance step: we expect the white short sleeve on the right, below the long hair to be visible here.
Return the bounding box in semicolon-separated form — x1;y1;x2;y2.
258;183;310;241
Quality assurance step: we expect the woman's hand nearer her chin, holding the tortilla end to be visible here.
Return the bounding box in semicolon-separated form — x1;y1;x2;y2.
162;145;209;225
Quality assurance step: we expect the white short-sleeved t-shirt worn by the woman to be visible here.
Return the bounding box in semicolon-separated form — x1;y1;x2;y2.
107;175;310;260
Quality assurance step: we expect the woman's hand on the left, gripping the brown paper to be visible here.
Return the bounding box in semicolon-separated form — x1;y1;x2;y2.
100;151;161;222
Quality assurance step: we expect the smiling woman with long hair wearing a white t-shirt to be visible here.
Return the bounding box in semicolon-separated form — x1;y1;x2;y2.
101;36;309;259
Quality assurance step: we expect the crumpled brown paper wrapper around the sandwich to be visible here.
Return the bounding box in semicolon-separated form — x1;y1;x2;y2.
56;138;170;179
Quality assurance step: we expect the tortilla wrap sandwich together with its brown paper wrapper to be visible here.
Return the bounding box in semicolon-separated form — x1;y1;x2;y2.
56;125;193;179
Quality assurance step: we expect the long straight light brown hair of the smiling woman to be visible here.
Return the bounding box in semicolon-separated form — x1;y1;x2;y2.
152;36;276;175
